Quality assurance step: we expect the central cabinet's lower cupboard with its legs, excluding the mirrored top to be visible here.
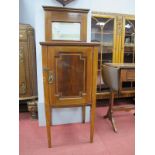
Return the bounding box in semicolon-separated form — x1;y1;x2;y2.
40;41;99;147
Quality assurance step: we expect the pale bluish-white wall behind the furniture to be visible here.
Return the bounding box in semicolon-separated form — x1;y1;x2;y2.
19;0;135;126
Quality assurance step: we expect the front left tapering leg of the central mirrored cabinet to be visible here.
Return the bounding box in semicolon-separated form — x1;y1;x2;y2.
46;106;52;148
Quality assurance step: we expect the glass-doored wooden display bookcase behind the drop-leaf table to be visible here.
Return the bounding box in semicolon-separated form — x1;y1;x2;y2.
91;12;135;99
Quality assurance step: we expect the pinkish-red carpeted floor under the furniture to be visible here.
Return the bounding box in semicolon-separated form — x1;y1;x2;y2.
19;107;135;155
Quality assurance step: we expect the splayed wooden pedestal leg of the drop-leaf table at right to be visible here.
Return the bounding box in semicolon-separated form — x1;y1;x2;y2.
104;91;117;132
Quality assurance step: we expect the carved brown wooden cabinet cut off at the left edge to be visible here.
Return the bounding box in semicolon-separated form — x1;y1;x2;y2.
19;24;38;118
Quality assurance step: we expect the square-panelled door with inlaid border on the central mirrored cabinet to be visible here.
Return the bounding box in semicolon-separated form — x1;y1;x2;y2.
48;46;92;106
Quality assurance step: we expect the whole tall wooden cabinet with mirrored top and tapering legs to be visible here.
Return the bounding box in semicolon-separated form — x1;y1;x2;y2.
41;6;99;147
